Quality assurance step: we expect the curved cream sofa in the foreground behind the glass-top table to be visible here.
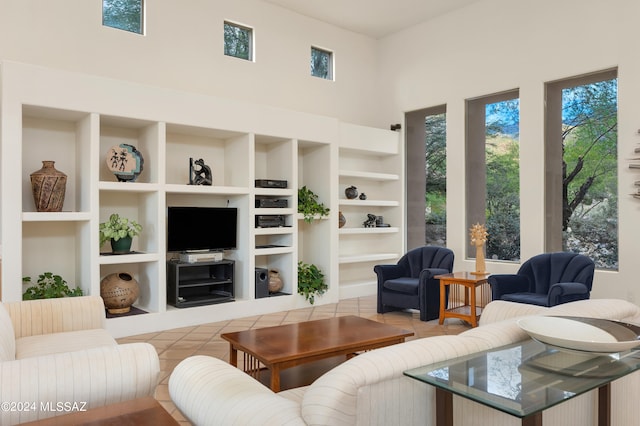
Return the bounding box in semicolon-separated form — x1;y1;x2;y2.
169;299;640;426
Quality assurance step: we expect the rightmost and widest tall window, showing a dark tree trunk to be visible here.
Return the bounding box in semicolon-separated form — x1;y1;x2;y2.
545;70;618;270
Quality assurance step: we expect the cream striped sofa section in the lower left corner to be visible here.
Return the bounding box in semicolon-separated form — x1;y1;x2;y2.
0;296;160;425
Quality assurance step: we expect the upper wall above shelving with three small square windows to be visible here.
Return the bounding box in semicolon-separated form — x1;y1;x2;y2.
0;0;380;127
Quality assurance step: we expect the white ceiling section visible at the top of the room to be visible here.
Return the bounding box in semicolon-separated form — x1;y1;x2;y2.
264;0;481;38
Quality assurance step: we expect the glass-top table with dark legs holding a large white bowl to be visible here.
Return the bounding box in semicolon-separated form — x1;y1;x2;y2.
404;340;640;426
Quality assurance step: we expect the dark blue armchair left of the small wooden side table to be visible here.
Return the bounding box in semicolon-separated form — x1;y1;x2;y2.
373;246;454;321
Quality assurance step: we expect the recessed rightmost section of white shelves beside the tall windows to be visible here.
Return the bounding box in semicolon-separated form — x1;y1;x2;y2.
338;124;405;298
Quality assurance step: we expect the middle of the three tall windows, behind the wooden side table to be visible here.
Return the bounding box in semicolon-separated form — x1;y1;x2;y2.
466;91;520;262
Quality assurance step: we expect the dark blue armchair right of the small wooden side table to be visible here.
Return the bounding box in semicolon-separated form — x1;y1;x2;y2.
488;252;595;306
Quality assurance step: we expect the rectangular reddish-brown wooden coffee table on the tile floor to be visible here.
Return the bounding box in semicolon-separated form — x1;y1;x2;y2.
222;315;413;392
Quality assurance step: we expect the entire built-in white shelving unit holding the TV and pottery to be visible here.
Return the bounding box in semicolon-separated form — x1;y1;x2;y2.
0;62;404;337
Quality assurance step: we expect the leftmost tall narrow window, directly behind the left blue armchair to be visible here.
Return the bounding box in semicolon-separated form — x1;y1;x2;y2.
405;105;447;248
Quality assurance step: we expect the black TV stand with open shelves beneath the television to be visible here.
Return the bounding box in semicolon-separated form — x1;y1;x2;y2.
167;259;235;308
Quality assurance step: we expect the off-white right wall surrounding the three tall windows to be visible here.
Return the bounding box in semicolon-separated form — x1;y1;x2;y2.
378;0;640;302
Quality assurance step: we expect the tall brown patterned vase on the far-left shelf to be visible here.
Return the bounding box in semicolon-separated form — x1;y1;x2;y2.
31;161;67;212
